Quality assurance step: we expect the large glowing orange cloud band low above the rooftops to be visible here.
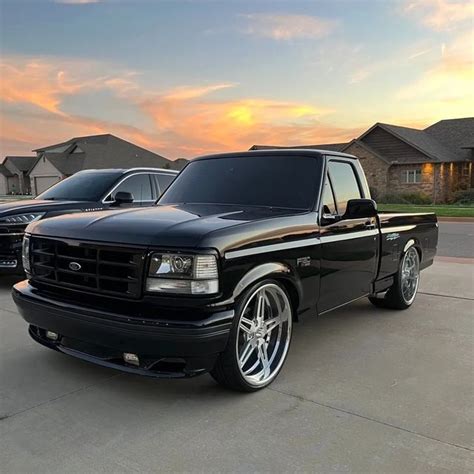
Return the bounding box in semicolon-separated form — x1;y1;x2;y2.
0;57;359;158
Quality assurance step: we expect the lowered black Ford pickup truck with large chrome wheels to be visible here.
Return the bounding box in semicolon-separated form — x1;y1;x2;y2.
13;150;438;391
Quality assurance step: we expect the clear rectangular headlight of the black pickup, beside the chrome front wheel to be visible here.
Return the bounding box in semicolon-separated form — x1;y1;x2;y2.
146;253;219;295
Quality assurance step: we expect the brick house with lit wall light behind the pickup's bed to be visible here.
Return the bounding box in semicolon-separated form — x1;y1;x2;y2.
250;117;474;203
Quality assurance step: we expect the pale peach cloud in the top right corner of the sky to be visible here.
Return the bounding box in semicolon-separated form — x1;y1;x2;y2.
403;0;474;30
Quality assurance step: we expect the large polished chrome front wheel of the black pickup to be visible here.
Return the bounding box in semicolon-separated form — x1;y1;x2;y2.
236;283;292;387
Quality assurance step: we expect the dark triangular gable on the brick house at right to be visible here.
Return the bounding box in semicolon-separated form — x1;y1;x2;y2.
360;127;433;163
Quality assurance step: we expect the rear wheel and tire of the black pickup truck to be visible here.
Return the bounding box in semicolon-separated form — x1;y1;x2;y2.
369;246;420;309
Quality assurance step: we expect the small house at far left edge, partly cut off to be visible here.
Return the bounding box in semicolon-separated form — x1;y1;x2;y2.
0;156;36;194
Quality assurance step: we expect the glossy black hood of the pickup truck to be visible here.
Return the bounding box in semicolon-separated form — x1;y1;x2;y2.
27;204;316;252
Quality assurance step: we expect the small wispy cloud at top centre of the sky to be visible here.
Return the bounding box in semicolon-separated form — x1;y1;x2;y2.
242;13;338;40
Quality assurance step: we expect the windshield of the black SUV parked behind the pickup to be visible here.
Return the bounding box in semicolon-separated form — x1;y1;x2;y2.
35;172;121;201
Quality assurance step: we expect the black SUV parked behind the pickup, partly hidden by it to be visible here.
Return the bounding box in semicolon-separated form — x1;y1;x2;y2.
0;168;178;274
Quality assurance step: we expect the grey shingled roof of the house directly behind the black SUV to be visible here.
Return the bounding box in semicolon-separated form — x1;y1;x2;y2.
30;134;171;175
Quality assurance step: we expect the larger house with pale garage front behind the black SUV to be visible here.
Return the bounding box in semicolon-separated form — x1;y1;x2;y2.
29;134;172;195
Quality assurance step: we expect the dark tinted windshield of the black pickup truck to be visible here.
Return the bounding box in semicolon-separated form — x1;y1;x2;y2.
158;154;321;209
